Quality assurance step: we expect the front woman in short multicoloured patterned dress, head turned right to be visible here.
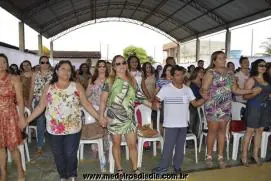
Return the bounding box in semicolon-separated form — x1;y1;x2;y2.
201;51;252;168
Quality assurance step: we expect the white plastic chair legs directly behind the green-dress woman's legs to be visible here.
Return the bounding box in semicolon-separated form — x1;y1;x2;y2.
108;135;129;173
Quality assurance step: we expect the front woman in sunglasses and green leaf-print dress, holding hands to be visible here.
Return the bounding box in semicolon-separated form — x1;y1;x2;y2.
99;55;155;174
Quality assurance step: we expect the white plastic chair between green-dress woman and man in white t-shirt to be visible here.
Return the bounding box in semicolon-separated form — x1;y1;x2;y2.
134;104;164;168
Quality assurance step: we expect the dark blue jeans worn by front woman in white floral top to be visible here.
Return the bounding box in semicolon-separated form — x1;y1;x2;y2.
47;132;81;179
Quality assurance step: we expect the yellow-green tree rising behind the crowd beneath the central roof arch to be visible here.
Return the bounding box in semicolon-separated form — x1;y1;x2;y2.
123;45;149;63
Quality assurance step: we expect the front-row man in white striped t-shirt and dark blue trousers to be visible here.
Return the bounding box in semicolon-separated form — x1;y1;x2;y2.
152;65;205;174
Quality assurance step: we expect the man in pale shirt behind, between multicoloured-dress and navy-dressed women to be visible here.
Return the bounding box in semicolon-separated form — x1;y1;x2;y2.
235;56;249;103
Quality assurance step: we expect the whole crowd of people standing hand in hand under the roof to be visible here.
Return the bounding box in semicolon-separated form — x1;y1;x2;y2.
0;51;271;181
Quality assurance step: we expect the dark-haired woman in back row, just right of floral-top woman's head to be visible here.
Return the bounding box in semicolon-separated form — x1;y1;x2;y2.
77;63;91;90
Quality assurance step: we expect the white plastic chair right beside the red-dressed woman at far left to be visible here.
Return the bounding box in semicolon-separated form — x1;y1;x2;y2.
7;106;31;171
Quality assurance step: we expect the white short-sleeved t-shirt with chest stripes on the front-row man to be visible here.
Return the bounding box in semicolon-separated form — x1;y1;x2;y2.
157;83;195;128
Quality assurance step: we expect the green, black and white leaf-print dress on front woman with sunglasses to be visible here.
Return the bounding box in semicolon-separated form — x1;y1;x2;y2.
103;77;146;135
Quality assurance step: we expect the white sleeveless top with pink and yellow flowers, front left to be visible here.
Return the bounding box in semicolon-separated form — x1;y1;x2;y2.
45;82;82;135
